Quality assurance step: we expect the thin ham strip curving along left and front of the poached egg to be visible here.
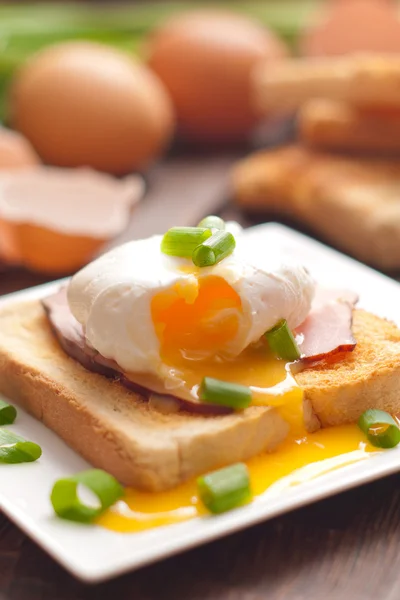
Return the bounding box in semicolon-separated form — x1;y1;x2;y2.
42;288;232;415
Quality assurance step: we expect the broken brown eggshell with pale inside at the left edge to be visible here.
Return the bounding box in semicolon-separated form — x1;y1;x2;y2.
0;166;144;275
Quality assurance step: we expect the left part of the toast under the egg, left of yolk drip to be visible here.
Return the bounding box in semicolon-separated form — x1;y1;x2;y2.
0;301;288;491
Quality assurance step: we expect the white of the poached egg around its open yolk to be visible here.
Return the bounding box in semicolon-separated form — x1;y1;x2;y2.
68;225;315;389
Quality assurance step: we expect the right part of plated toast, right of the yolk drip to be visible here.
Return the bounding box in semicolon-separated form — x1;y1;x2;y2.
296;310;400;427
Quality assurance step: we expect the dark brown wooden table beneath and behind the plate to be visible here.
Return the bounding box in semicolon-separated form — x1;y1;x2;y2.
0;156;400;600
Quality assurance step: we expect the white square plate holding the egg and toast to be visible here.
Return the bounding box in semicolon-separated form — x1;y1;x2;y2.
0;223;400;582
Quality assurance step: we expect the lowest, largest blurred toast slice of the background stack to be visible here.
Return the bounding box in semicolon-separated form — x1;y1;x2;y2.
232;145;400;270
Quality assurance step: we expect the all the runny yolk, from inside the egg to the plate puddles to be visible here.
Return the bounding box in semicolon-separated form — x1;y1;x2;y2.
98;273;374;532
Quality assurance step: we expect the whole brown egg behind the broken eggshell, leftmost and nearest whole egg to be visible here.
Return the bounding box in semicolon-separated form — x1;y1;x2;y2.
10;42;174;174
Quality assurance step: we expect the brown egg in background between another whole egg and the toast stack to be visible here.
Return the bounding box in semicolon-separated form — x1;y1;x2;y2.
148;10;287;142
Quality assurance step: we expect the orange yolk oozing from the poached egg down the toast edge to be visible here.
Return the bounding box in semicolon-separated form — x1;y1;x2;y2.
151;272;302;425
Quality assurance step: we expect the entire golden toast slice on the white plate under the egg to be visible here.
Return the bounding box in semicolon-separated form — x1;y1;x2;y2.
0;301;400;491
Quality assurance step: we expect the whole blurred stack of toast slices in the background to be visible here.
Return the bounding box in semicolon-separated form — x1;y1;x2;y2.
232;43;400;271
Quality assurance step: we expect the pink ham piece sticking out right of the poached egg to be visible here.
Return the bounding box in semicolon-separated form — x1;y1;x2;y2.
295;288;358;363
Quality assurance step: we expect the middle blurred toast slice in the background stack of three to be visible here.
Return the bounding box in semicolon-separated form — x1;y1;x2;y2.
297;98;400;154
